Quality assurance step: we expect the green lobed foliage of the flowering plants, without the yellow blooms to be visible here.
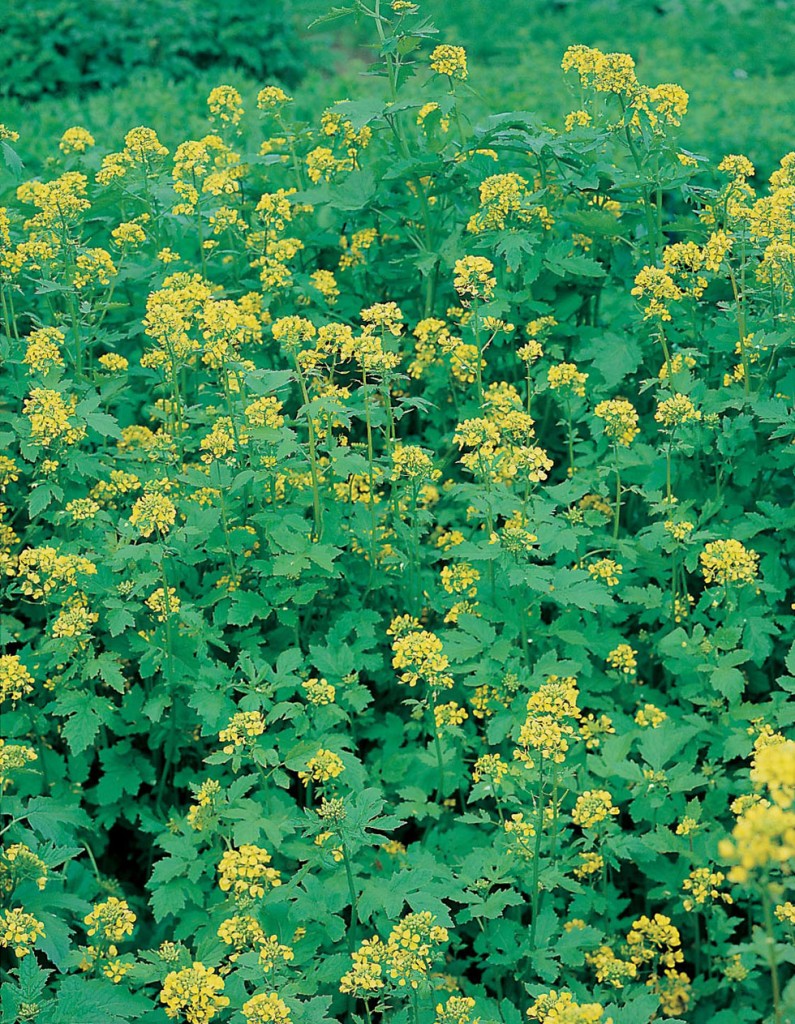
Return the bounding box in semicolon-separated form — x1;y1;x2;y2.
0;2;795;1024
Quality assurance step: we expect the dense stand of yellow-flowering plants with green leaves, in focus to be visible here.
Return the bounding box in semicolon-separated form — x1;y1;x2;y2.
0;0;795;1024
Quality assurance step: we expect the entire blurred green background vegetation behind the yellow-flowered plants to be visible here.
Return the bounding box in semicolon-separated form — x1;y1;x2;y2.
0;0;795;174
